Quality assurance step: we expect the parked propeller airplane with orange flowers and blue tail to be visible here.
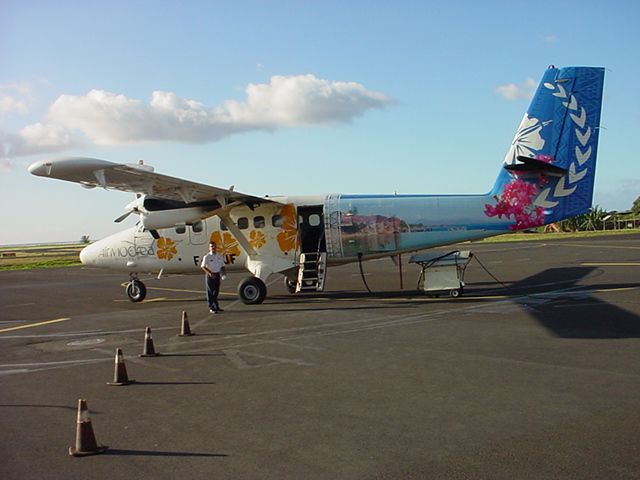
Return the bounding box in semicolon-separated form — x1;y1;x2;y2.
29;65;604;305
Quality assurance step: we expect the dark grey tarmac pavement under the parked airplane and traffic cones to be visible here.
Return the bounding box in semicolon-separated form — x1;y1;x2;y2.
0;235;640;480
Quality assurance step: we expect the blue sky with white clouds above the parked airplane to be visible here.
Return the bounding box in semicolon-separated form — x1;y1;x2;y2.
0;0;640;244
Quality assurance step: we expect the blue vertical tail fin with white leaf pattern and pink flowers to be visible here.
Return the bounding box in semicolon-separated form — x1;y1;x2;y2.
485;66;604;230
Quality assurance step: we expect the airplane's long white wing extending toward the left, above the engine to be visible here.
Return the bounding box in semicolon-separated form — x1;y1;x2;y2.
29;157;277;206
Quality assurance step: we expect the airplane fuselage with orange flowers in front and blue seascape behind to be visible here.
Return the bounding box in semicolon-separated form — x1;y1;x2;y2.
80;191;508;278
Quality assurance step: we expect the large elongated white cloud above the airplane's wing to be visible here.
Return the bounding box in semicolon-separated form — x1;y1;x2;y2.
4;75;394;156
